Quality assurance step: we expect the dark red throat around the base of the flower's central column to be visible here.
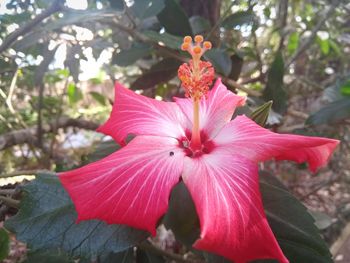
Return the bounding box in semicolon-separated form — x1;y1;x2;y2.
179;131;215;158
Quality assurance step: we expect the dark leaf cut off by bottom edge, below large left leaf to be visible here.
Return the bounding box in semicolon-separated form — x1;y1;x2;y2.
23;250;74;263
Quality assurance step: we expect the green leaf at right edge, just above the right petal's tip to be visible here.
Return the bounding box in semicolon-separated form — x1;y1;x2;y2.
305;98;350;125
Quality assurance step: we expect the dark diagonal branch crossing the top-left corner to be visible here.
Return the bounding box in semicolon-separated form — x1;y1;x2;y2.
0;0;64;53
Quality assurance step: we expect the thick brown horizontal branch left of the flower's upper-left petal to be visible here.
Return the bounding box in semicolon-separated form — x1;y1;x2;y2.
0;117;99;151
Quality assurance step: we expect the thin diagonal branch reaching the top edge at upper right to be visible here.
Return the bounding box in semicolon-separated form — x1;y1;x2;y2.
285;0;340;68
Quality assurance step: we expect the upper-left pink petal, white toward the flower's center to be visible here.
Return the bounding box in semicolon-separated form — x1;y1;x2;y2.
97;83;188;144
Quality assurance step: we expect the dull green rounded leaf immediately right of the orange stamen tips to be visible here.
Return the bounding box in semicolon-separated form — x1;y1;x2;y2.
204;48;232;76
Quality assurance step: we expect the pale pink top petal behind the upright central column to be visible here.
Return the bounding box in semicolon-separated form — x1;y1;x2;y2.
175;79;246;138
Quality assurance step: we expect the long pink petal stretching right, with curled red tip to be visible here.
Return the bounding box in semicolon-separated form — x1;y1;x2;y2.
214;116;339;171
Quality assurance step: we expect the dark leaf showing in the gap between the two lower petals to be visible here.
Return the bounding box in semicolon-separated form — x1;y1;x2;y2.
163;182;200;247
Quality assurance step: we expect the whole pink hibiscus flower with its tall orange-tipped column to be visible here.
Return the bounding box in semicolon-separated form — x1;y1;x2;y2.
59;36;339;263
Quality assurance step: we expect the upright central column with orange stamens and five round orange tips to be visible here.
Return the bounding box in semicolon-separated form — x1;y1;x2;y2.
178;35;214;152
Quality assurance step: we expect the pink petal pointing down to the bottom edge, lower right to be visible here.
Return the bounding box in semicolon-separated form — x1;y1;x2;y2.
182;151;288;263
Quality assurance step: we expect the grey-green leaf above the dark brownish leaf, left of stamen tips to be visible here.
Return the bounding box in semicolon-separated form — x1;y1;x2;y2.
112;46;151;67
